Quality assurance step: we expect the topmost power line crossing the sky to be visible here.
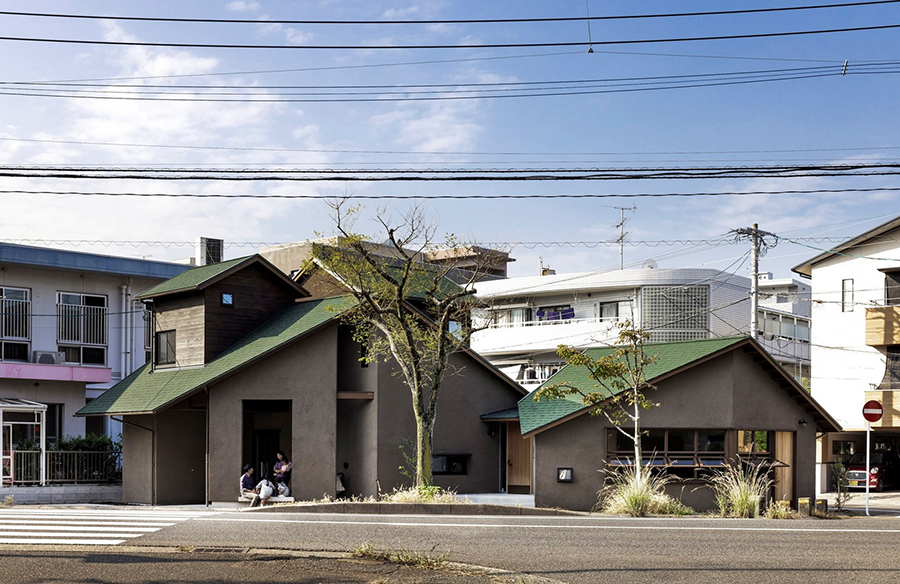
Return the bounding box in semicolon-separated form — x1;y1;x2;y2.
0;0;900;26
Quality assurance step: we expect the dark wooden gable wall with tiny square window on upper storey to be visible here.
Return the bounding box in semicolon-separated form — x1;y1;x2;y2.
204;264;300;363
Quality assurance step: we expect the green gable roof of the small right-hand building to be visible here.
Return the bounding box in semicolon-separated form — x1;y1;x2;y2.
519;337;840;436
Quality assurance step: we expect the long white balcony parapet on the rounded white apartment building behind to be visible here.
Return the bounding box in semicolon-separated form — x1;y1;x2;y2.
471;318;618;355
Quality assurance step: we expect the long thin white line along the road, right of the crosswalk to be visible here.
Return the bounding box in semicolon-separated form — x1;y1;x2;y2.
195;515;900;534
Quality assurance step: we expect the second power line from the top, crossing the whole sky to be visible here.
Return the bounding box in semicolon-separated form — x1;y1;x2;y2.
0;24;900;51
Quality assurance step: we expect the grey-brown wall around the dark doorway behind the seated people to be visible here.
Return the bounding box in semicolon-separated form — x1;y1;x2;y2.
210;326;337;501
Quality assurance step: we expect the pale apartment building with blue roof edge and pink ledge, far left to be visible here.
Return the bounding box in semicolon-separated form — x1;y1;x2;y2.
0;243;190;453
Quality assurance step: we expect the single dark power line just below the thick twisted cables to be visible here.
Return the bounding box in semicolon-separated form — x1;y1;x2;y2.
0;186;900;200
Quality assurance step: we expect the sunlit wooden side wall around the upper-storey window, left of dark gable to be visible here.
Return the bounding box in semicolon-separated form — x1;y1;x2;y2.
153;294;206;367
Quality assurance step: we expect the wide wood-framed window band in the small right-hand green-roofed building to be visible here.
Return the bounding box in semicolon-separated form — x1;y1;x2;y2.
607;428;725;479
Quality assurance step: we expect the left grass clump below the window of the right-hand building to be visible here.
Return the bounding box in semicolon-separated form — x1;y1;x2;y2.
597;466;694;517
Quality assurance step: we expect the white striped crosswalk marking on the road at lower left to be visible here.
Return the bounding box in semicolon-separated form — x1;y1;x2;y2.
0;508;213;545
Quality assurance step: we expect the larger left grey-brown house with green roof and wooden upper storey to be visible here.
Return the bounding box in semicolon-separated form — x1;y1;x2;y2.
79;256;530;504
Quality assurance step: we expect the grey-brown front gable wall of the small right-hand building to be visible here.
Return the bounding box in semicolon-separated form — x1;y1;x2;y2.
535;350;816;510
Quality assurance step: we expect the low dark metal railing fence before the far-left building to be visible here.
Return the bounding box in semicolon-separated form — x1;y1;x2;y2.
3;450;122;485
